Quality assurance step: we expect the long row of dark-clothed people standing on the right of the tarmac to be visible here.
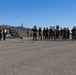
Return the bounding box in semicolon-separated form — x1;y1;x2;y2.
32;26;76;41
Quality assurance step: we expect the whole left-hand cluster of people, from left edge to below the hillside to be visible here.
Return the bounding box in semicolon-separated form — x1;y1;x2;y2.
0;27;20;40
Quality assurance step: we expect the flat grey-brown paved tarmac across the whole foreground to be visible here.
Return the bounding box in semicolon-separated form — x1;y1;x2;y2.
0;38;76;75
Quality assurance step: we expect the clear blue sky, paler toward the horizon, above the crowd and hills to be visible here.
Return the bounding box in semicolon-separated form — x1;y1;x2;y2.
0;0;76;29
